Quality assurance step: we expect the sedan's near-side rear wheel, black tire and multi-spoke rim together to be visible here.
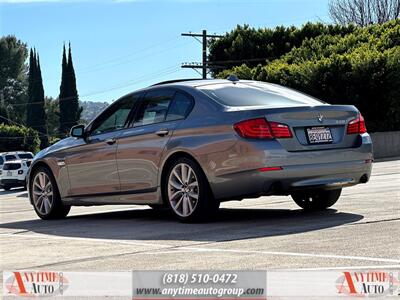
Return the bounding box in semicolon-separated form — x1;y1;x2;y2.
163;157;219;222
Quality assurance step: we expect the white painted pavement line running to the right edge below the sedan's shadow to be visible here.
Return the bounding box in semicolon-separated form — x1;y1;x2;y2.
179;246;400;263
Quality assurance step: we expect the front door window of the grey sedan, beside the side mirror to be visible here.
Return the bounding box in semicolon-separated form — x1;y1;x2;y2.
91;96;139;135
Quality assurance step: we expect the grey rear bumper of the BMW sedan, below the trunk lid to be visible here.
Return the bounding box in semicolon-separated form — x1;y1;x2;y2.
211;134;373;200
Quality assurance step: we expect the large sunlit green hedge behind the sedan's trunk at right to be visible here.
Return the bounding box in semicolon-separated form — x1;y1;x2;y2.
218;20;400;132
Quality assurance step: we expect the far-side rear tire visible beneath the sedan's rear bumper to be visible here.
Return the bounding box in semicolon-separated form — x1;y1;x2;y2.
291;189;342;210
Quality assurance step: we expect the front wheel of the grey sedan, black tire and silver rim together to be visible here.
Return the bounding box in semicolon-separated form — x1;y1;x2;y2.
29;167;71;220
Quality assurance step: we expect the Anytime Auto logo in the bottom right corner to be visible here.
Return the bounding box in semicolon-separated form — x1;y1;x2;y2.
336;271;400;297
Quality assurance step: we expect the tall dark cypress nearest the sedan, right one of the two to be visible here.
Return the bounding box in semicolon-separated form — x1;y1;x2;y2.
59;45;82;135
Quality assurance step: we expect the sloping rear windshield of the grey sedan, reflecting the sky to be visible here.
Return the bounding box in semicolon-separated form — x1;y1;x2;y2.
198;82;324;107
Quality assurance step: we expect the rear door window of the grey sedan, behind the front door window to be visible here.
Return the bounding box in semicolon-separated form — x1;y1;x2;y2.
134;90;174;127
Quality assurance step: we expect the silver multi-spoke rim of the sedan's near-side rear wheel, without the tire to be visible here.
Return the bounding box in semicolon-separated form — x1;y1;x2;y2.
168;163;200;217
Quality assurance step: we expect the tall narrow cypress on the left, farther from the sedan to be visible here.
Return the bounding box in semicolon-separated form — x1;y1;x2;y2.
26;50;48;149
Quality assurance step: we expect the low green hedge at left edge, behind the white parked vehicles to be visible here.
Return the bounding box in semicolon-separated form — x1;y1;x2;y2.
0;124;40;153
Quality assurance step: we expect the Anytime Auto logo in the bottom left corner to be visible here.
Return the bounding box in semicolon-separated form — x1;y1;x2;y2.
5;271;68;296
